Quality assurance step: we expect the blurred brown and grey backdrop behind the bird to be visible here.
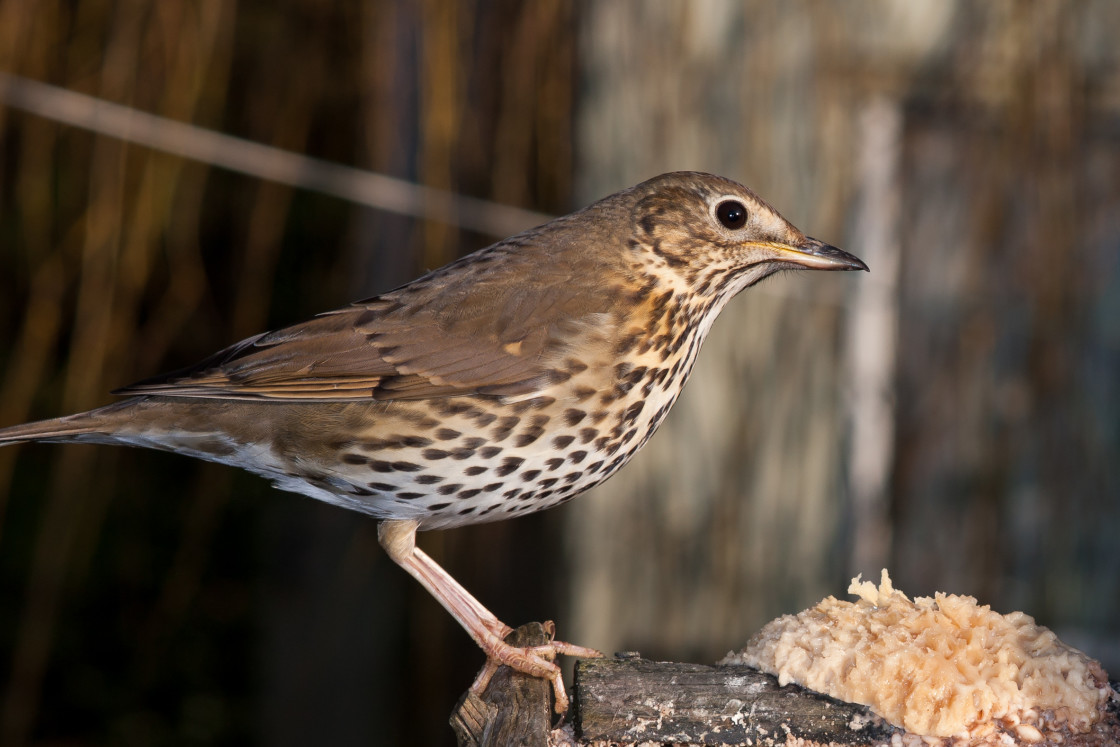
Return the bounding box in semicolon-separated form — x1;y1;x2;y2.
0;0;1120;746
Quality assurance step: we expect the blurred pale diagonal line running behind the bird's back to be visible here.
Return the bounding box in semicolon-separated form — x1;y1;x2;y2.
0;72;552;237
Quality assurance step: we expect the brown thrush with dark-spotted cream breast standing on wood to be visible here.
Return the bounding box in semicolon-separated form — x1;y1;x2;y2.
0;171;868;715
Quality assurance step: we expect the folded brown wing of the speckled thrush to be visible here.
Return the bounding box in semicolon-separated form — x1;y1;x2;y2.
116;242;617;401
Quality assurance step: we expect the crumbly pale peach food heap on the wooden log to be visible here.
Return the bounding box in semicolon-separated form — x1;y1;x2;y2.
722;570;1111;740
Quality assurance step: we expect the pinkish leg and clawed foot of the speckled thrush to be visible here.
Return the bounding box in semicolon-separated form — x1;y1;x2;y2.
377;520;603;713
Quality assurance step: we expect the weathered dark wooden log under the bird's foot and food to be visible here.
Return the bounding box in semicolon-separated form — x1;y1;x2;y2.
451;645;1120;747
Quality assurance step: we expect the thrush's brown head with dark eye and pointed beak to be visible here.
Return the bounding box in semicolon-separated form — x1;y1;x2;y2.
623;171;867;306
